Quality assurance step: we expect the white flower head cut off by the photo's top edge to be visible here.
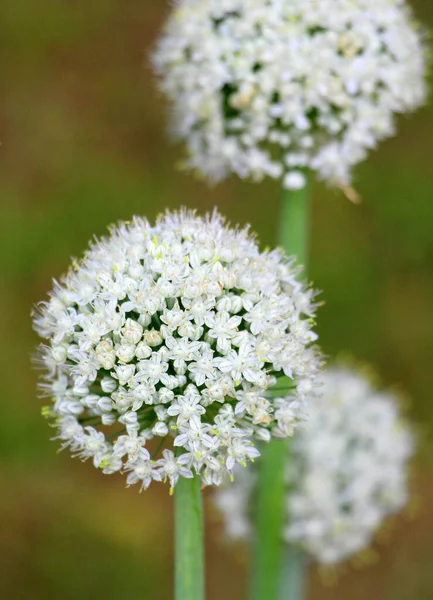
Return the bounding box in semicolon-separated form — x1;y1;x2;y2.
154;0;426;189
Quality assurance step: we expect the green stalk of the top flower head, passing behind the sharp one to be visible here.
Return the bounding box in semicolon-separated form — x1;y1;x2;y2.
251;175;309;600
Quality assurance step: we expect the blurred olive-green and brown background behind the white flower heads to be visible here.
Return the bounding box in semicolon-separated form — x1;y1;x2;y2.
0;0;433;600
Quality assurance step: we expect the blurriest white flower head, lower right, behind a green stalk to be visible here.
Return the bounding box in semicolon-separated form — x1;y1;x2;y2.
216;368;413;565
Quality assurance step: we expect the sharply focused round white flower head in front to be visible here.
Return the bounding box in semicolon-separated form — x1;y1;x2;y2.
34;212;320;489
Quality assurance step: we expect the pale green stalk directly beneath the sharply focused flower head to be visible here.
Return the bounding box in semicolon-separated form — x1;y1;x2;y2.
174;477;204;600
